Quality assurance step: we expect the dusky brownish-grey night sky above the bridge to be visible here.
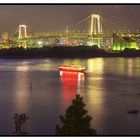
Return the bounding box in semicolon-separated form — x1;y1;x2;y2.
0;5;140;34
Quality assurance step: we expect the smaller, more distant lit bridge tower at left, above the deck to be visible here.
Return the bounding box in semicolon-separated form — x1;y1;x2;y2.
18;25;27;39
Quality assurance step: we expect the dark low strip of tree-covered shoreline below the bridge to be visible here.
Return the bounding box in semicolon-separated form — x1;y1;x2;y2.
0;46;140;58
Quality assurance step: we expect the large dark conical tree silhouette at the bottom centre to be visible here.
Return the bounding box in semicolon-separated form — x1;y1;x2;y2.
56;95;96;135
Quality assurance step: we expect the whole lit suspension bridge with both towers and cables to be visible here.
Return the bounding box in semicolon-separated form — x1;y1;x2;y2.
2;14;140;48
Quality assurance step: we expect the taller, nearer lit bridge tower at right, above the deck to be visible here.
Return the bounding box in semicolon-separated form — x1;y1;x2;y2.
90;14;102;35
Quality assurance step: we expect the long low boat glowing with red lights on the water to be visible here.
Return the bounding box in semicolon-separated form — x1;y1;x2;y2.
58;65;86;72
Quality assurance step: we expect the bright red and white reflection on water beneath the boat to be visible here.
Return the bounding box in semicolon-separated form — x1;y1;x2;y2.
60;71;85;106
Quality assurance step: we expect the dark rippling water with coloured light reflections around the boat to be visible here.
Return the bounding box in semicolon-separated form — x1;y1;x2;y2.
0;58;140;135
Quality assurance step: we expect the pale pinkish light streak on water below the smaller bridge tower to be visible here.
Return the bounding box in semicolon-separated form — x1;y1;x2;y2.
14;63;32;113
